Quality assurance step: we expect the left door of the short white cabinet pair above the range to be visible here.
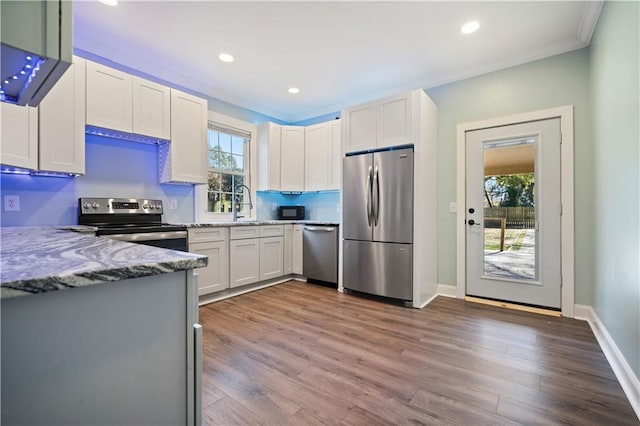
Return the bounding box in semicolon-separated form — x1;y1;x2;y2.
87;61;133;133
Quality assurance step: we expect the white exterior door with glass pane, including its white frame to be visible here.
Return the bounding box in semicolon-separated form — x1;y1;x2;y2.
456;106;574;317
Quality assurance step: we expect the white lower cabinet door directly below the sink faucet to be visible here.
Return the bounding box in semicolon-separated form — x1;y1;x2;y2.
229;238;260;288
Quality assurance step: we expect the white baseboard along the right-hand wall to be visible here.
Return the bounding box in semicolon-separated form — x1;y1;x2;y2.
575;305;640;419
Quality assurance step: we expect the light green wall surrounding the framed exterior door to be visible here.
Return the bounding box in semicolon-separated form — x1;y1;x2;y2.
426;48;594;305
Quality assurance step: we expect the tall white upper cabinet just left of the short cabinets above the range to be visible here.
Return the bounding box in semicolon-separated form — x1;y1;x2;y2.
38;57;86;174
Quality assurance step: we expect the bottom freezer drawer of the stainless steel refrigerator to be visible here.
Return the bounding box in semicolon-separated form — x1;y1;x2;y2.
343;240;413;300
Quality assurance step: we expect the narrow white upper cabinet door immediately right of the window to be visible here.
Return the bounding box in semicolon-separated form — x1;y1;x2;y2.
258;123;282;191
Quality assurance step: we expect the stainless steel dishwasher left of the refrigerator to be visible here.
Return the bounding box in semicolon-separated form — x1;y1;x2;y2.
302;225;338;285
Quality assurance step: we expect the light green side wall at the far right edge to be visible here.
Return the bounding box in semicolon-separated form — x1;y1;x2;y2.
590;2;640;377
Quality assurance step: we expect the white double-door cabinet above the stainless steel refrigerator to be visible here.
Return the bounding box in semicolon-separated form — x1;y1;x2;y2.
342;89;422;153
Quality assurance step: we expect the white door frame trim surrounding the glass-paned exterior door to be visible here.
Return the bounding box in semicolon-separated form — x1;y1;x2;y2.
456;105;575;318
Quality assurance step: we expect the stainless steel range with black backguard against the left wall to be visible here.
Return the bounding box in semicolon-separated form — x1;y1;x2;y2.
78;198;187;251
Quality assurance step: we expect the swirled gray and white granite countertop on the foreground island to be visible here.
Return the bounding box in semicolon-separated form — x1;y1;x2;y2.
0;227;208;299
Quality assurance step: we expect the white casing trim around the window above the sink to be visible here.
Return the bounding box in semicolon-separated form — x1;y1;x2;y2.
193;111;258;222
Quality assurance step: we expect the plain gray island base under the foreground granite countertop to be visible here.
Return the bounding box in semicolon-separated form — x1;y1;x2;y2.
1;270;197;425
